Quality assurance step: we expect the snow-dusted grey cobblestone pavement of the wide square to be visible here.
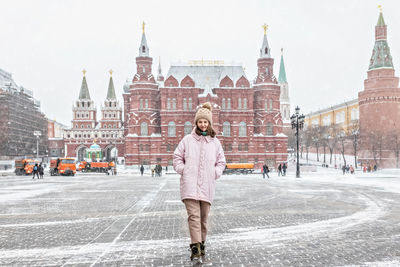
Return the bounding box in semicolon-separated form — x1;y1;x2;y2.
0;171;400;266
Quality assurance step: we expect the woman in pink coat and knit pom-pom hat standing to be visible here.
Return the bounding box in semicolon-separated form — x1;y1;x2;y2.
174;102;225;260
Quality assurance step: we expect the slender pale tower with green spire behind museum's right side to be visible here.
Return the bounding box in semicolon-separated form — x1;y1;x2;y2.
278;48;291;128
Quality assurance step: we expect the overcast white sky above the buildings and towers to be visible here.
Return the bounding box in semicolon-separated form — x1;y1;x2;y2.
0;0;400;126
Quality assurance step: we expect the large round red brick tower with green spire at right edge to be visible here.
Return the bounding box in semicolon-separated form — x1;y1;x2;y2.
358;6;400;167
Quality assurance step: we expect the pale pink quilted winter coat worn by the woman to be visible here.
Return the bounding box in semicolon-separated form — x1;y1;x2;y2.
174;129;225;204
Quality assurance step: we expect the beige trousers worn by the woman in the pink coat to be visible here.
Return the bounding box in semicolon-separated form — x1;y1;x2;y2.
183;199;211;244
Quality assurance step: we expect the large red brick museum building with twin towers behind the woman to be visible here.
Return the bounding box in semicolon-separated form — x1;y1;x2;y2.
123;27;289;168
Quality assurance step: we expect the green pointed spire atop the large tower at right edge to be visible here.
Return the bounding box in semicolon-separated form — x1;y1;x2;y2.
368;6;393;70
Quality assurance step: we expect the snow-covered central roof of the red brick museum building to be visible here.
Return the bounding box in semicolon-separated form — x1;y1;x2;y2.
166;65;247;95
